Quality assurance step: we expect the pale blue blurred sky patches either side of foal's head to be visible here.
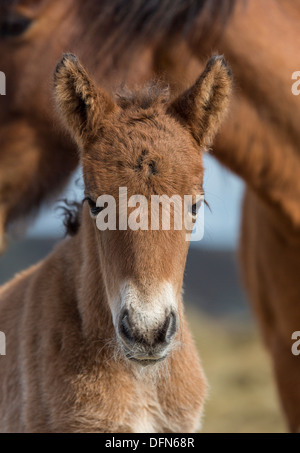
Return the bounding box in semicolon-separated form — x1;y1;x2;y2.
28;156;243;249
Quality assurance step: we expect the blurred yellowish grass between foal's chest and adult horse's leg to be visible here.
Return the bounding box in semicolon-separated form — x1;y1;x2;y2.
187;309;286;433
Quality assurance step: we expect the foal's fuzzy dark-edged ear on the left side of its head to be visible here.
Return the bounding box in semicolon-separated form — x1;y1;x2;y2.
54;54;116;144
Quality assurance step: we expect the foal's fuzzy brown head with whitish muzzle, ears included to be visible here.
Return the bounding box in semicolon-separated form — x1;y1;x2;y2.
55;55;231;365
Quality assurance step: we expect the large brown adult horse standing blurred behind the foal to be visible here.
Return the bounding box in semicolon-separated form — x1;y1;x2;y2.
0;0;300;430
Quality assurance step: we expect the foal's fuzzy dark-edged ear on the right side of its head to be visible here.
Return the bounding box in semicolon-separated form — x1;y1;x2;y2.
170;56;232;148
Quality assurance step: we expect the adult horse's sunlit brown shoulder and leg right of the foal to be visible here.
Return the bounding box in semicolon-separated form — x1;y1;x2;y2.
209;0;300;431
